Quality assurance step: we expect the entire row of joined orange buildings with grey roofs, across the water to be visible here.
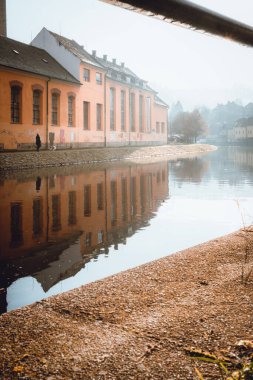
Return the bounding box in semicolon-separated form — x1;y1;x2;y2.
0;28;168;150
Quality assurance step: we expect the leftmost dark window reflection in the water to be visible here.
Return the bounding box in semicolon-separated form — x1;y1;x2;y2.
11;203;23;247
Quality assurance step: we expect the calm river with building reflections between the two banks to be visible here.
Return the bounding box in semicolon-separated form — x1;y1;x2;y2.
0;147;253;313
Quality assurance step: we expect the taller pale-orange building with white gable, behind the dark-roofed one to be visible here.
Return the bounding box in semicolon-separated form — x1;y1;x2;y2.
32;28;168;146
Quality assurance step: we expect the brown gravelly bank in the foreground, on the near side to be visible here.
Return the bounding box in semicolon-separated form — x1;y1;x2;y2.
0;229;253;380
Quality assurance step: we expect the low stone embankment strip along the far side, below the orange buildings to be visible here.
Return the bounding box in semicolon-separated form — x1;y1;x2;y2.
0;144;216;172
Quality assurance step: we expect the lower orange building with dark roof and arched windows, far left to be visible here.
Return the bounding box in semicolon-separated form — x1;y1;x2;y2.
0;37;80;150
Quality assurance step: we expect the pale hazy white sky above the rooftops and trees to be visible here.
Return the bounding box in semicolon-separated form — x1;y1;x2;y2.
6;0;253;108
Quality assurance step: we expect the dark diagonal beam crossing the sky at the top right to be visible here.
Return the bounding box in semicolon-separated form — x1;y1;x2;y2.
102;0;253;46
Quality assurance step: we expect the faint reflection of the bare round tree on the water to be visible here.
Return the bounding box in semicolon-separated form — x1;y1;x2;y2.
171;157;209;183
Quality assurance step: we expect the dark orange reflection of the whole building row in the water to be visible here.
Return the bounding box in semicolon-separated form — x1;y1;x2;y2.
0;162;168;314
